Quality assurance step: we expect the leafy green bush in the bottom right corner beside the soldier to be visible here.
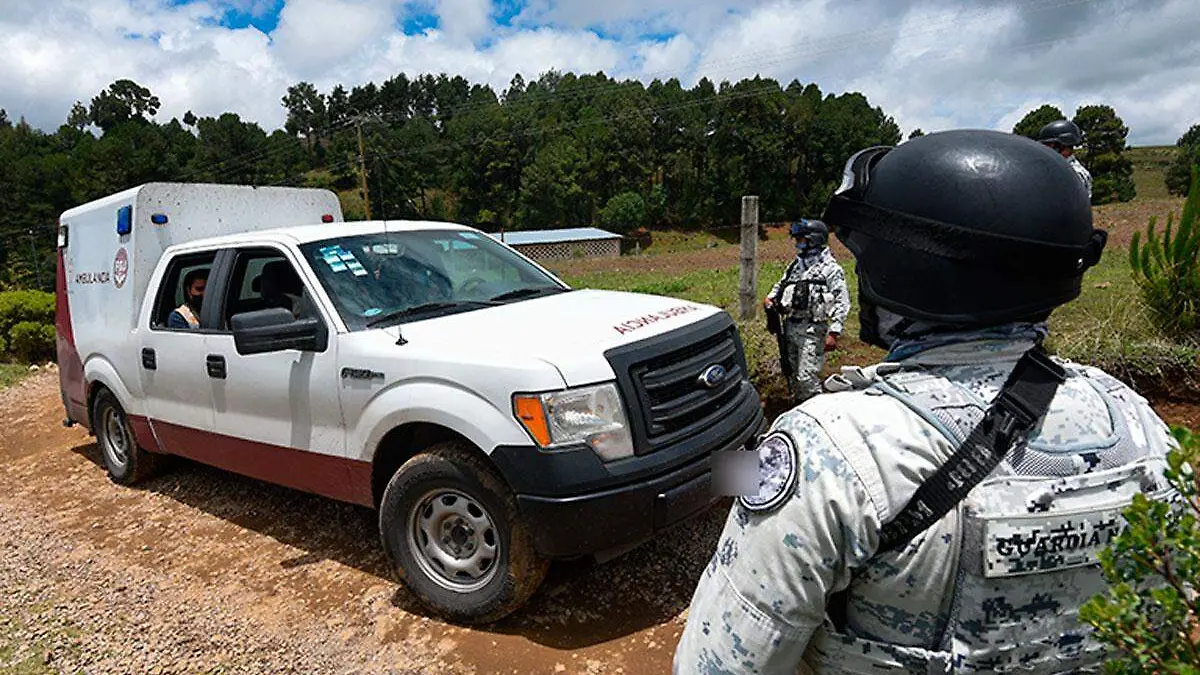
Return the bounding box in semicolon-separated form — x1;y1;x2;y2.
1079;429;1200;674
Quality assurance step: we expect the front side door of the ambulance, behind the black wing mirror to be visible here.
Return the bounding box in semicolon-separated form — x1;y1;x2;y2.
206;246;346;458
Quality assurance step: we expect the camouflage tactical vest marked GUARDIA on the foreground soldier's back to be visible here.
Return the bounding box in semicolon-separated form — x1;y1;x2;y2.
805;364;1171;675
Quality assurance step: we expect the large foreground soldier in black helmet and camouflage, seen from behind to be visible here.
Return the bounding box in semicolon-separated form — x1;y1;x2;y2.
674;131;1174;675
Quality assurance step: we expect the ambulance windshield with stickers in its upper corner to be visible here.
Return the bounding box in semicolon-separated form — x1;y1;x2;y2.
300;229;566;330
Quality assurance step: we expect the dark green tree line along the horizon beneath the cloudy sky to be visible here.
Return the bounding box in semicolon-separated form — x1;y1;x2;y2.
0;71;1200;288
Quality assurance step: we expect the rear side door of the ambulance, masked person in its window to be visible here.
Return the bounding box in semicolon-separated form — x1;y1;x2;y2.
136;251;217;444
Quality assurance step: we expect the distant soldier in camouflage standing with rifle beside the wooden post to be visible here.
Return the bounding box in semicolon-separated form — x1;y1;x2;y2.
763;220;850;404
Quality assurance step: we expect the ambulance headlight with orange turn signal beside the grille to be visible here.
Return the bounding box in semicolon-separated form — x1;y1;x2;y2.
512;383;634;461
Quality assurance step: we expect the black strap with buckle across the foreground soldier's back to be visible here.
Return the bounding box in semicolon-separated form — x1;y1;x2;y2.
878;345;1067;552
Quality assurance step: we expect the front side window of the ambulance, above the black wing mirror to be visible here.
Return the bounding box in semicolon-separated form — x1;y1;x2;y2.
221;249;316;330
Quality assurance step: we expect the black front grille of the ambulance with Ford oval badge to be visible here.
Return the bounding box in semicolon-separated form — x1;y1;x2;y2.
610;318;754;455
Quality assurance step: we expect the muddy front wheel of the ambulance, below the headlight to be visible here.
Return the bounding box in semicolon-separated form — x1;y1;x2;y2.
379;441;550;623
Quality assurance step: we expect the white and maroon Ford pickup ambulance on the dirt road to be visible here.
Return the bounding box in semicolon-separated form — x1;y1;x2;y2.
56;184;763;622
